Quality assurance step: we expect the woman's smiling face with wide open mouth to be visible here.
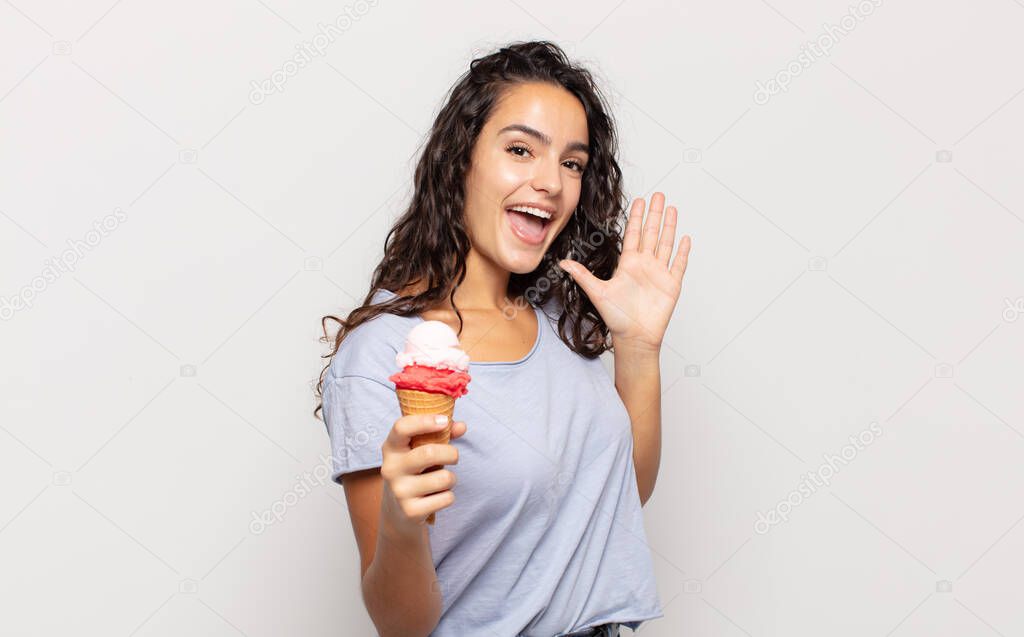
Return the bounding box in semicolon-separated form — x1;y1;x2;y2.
466;83;589;274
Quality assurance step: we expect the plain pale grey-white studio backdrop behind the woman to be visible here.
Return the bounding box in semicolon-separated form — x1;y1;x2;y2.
0;0;1024;637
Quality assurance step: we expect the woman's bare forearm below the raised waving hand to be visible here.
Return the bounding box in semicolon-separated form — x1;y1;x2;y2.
614;346;662;505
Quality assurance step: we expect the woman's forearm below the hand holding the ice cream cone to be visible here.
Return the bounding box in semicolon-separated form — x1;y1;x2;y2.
362;519;441;637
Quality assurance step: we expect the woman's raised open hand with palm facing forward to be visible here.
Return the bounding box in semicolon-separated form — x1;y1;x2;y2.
559;193;690;350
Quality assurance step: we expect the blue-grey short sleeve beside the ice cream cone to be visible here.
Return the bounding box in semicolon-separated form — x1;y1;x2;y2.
324;376;401;484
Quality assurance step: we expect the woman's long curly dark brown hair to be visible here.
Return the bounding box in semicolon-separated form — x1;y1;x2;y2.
313;41;628;417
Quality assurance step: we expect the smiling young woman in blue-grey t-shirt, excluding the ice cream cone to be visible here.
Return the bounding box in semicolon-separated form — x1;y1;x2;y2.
317;42;690;637
